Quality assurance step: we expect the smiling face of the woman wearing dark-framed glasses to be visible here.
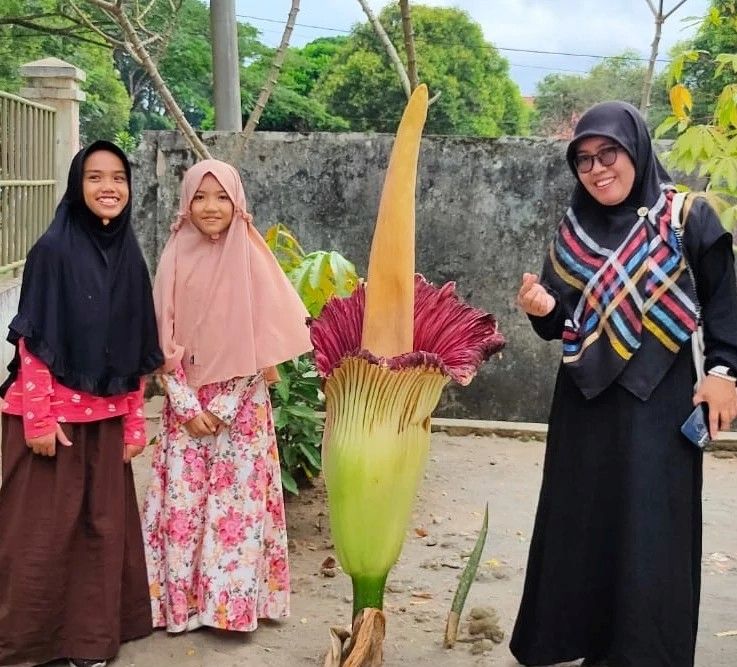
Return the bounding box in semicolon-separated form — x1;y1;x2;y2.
574;137;635;206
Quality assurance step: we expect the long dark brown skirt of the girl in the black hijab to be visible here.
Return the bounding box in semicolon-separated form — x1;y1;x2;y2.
0;415;152;665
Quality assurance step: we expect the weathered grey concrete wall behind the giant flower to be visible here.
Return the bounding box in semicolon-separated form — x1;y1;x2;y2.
134;132;573;421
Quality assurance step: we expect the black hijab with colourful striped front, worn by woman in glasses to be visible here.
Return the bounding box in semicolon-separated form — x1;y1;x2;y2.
542;102;696;400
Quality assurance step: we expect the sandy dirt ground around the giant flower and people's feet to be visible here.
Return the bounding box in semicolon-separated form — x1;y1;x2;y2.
114;433;737;667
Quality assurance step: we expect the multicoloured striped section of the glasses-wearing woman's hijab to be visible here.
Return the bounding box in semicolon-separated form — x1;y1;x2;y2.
550;190;697;367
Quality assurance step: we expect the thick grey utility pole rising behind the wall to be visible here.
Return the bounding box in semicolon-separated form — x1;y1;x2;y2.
210;0;241;132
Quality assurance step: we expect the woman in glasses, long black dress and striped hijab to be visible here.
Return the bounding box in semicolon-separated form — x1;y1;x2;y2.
510;102;737;667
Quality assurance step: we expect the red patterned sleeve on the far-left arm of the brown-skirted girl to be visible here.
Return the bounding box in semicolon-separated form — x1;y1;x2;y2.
18;338;56;439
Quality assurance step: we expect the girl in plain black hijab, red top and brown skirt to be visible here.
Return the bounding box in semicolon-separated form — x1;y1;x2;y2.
0;141;163;667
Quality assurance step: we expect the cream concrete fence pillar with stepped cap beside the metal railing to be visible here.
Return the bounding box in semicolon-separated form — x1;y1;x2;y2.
20;58;87;201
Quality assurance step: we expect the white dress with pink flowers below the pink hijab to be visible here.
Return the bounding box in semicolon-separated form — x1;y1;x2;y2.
143;368;289;632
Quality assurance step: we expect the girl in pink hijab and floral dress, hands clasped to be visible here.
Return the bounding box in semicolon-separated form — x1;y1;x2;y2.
143;160;312;632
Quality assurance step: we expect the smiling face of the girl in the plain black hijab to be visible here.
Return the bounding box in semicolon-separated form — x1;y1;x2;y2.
82;150;130;225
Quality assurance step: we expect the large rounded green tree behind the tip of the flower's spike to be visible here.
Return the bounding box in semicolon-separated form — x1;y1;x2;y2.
313;4;526;136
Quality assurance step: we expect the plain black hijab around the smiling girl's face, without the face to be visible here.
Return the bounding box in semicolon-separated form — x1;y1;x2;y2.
0;141;163;396
